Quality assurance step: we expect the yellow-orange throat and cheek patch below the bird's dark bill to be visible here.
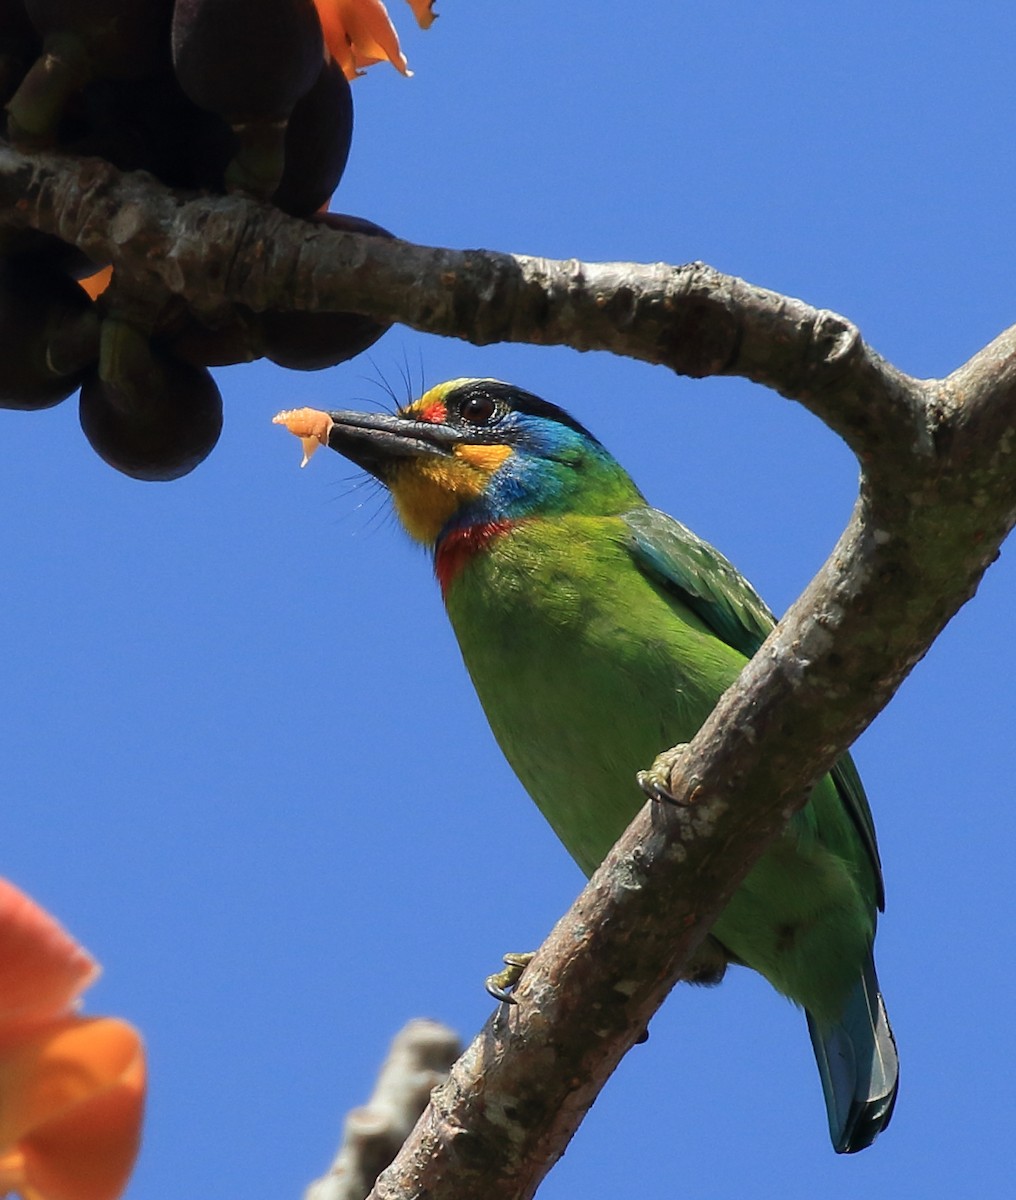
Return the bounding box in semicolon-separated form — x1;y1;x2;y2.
389;445;512;546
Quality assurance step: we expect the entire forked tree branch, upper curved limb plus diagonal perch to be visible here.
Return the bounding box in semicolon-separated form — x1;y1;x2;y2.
0;138;1016;1200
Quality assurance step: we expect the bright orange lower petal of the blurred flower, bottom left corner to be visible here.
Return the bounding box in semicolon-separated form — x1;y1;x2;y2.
0;1016;145;1200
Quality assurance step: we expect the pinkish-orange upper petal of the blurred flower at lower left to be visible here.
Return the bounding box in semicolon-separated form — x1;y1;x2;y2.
0;878;98;1036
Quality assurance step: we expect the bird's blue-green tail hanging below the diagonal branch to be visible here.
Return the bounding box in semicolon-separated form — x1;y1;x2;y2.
807;954;900;1154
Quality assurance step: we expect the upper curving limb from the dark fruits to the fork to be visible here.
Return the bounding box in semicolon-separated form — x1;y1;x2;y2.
0;140;930;461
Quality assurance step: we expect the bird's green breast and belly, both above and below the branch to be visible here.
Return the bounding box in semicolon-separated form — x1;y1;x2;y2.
446;516;874;1015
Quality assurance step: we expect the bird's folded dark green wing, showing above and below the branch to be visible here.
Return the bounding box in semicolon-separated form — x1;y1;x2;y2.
621;508;885;908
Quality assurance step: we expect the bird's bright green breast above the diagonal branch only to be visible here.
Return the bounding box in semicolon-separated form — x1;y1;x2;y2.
446;517;745;874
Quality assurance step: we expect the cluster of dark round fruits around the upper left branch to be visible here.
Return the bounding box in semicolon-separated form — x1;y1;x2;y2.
0;0;391;480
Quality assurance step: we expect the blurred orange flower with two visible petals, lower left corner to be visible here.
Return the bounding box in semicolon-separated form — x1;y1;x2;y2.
0;880;145;1200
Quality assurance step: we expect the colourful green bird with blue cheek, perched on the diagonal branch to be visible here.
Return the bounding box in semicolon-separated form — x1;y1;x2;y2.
279;379;898;1153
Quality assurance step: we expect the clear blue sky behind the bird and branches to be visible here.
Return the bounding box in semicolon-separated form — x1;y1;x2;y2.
0;9;1016;1200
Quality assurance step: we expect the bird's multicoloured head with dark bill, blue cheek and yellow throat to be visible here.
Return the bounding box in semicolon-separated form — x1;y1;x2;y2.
296;379;642;546
